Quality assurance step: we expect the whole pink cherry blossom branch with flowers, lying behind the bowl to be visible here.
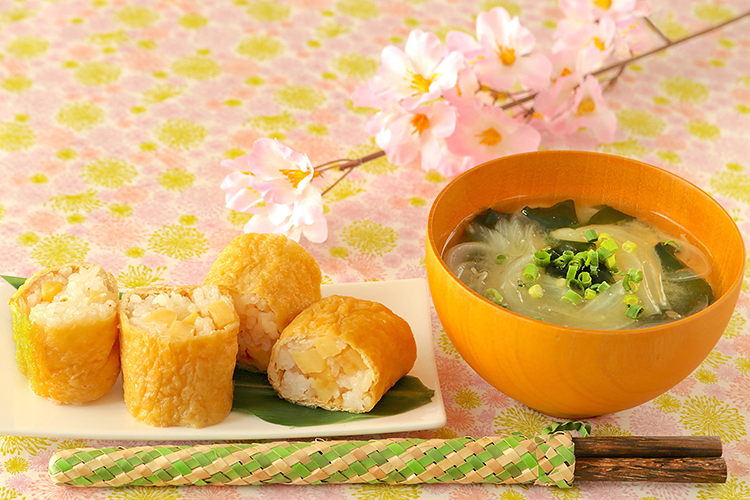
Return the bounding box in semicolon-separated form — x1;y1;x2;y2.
221;5;750;243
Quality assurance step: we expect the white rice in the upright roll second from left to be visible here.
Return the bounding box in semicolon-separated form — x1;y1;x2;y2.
125;285;232;336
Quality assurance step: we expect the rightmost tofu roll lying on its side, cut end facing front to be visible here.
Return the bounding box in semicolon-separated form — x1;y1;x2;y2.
268;295;417;413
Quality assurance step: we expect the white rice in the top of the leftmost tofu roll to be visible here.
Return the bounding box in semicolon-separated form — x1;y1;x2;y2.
26;266;118;328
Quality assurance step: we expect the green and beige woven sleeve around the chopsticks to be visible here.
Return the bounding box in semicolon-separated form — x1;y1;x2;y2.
49;432;575;488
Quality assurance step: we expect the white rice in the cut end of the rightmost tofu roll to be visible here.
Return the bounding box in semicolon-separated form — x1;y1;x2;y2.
277;339;373;411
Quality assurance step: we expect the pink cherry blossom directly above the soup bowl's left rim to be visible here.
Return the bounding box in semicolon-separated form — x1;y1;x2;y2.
446;101;541;165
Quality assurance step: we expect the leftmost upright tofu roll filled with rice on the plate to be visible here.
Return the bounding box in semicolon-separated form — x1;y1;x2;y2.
10;263;120;403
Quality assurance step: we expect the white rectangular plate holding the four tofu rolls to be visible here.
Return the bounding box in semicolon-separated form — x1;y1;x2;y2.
0;278;445;441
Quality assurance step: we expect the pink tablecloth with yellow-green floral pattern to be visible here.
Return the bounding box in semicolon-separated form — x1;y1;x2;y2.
0;0;750;500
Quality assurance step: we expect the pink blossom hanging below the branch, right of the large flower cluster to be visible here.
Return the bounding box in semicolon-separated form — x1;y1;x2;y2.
549;75;617;143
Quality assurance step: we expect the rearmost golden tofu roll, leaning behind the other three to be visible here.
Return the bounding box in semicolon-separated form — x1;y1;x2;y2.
203;233;321;372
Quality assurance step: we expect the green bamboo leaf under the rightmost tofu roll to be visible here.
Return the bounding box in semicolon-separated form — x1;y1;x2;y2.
233;370;435;427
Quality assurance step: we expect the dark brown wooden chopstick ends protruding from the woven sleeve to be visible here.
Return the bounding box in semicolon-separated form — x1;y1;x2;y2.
573;436;727;483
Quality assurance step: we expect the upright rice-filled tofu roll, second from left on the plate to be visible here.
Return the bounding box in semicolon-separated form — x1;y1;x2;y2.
120;285;239;428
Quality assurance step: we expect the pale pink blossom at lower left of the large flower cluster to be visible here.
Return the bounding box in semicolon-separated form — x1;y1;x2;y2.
375;101;456;170
